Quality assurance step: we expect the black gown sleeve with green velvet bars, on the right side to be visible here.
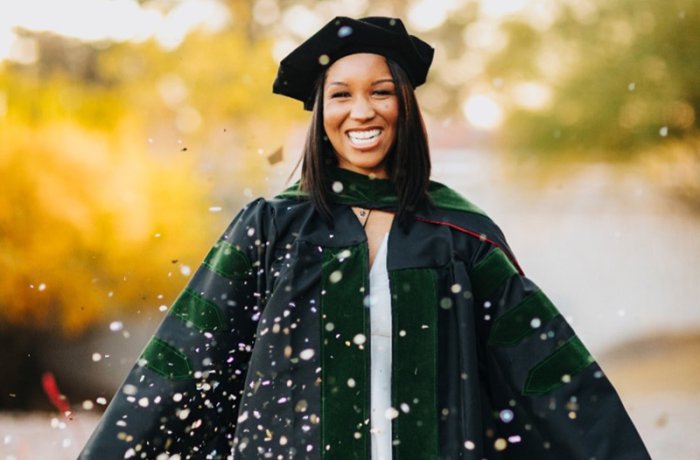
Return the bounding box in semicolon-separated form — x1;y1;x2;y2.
469;226;650;460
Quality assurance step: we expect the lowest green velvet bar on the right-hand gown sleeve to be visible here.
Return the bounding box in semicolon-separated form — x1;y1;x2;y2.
523;336;594;395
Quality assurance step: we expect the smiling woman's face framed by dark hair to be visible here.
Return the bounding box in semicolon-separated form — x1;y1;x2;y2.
323;53;399;178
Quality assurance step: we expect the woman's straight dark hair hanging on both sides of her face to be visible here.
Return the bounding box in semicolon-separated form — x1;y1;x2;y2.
301;59;430;228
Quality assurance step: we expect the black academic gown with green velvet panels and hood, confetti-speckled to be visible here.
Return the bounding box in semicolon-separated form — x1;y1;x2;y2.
81;169;649;460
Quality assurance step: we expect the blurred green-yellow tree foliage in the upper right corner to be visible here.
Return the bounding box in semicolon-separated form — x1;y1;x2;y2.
487;0;700;158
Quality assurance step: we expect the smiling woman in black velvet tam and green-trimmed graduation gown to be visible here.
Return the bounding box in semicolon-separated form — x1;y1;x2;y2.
82;17;649;460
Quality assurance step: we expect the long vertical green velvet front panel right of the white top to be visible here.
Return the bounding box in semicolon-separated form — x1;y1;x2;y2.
389;269;438;460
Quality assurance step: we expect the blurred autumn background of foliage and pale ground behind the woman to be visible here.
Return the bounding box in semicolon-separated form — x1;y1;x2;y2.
0;0;700;460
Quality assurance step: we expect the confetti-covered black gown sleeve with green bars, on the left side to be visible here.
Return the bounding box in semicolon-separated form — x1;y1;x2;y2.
79;199;269;460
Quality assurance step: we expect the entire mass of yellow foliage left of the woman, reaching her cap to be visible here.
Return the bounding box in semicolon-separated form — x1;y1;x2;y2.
0;28;307;334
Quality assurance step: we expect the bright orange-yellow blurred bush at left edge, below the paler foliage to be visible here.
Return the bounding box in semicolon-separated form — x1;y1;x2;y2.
0;121;220;333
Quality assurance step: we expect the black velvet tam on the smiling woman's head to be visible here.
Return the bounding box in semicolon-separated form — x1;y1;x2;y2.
272;16;435;110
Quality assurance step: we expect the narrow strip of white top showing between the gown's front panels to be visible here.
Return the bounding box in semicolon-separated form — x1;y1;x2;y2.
369;233;392;460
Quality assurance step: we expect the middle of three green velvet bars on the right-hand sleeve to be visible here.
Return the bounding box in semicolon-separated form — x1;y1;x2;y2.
489;291;559;346
